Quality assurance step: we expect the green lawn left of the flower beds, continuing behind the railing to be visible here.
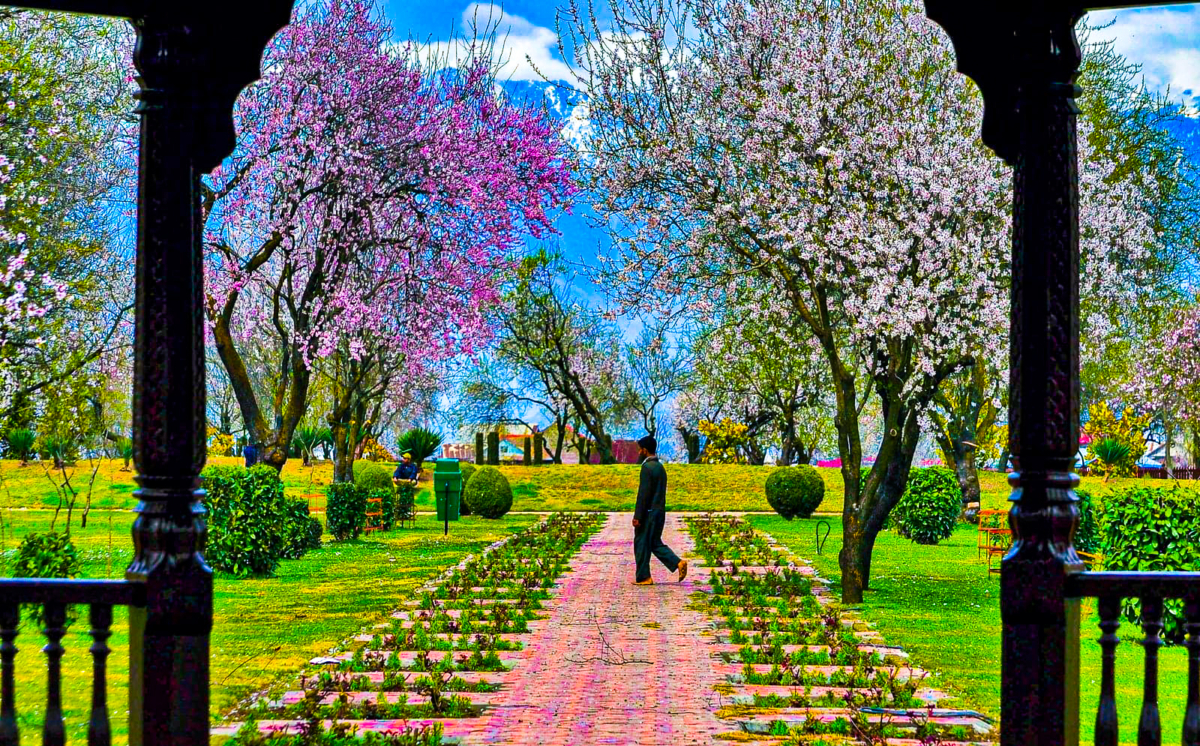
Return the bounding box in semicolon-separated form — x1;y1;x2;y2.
0;511;536;744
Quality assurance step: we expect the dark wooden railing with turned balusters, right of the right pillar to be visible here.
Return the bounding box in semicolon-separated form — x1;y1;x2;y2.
1067;572;1200;746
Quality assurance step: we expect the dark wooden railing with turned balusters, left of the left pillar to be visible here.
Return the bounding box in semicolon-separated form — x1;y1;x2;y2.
0;578;144;746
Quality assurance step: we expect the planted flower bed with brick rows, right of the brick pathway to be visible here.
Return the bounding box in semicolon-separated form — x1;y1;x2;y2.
688;516;994;745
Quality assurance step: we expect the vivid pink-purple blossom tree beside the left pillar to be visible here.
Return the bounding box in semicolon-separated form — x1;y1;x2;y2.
204;0;572;476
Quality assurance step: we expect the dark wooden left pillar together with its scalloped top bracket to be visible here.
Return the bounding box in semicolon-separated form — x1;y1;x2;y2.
0;0;293;746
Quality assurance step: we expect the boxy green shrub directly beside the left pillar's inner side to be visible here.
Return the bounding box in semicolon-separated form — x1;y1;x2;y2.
200;464;286;577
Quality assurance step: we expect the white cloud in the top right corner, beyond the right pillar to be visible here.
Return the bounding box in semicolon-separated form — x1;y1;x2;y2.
1086;6;1200;107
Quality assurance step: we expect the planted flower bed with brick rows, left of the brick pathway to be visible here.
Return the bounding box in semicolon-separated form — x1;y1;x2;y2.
218;515;602;746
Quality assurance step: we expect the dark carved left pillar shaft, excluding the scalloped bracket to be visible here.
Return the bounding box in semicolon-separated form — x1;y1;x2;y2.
126;18;212;745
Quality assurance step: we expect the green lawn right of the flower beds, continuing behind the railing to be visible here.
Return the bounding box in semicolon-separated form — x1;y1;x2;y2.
750;516;1187;744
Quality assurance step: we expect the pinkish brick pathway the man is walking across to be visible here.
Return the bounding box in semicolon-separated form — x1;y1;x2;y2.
464;513;728;746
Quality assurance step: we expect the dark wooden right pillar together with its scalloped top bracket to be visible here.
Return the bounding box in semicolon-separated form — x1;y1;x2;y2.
925;0;1195;746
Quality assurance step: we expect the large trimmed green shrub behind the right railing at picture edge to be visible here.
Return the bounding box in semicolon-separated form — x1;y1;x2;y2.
1099;486;1200;644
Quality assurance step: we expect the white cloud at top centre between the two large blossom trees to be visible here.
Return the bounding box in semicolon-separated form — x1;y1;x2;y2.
420;2;572;80
